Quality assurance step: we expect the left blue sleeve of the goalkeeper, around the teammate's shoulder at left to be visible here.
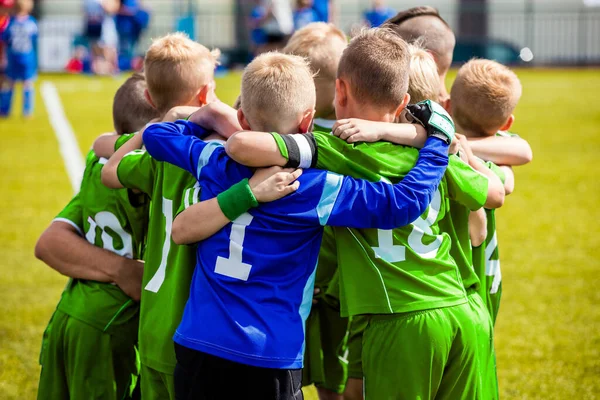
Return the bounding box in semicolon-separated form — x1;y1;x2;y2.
143;121;212;178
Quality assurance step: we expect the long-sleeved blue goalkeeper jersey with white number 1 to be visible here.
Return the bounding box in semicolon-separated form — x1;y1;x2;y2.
144;121;448;369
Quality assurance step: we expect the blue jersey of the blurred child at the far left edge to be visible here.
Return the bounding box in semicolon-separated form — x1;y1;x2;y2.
2;16;38;80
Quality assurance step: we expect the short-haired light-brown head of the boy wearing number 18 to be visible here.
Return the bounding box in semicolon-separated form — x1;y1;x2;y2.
338;28;410;107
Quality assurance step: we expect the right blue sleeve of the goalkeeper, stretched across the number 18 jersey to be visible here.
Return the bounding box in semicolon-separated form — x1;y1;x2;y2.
317;138;448;229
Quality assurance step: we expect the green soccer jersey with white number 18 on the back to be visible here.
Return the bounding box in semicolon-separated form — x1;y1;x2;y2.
274;132;488;316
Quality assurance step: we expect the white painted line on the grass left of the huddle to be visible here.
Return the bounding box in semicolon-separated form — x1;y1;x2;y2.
40;81;85;193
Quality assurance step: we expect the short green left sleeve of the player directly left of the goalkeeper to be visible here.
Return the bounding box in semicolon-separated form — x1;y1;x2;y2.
117;150;158;197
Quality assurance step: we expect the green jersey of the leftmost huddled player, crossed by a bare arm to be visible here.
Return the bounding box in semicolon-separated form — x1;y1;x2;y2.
58;135;148;332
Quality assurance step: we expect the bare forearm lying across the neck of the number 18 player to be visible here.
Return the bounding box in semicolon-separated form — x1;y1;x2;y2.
332;118;427;149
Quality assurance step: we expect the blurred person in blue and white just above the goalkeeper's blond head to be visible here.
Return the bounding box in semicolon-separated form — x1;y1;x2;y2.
249;0;294;55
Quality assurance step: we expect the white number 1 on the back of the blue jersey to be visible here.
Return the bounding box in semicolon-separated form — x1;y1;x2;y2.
215;213;253;281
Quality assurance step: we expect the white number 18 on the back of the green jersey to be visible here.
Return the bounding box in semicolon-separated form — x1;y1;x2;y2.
373;189;442;263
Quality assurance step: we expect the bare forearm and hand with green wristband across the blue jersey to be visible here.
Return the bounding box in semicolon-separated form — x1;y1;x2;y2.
171;167;302;244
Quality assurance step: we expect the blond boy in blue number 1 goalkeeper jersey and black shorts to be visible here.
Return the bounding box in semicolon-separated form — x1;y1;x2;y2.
143;53;453;399
